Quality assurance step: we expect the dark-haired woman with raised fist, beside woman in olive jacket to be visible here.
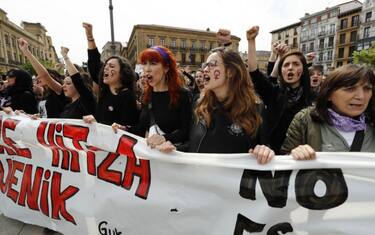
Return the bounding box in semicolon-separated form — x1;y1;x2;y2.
247;26;311;154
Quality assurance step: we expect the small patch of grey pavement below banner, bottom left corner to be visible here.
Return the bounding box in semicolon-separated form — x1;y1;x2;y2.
0;213;62;235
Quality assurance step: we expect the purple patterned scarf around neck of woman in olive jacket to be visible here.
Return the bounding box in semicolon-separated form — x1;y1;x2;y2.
328;108;366;132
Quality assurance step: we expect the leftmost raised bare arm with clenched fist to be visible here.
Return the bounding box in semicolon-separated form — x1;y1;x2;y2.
18;38;62;95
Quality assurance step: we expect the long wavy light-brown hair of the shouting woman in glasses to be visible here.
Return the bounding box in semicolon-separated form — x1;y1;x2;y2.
195;48;262;136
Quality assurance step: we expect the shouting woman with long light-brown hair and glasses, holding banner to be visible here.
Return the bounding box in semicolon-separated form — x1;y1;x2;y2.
158;48;274;164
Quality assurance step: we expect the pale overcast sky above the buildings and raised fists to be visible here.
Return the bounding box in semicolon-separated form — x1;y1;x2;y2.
0;0;348;64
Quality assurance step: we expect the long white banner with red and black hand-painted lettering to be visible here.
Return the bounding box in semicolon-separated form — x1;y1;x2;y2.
0;114;375;235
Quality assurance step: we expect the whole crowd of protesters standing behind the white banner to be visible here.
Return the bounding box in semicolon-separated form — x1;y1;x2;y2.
0;23;375;164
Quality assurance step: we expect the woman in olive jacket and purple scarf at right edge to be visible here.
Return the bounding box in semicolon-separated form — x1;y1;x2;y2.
281;65;375;160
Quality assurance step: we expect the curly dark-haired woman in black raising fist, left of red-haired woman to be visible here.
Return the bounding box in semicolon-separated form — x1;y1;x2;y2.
83;23;139;126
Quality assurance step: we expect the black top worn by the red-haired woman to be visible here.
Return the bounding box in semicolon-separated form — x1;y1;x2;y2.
134;89;192;144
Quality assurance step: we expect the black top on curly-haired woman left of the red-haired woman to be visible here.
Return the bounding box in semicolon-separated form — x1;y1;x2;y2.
95;89;139;126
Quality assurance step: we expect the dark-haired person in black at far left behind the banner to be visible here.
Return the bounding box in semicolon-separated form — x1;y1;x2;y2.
4;69;38;114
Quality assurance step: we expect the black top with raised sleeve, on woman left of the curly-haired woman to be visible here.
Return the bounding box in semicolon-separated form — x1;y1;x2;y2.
60;73;96;119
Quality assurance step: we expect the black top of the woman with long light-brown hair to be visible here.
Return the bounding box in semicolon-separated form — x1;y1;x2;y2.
189;104;259;153
